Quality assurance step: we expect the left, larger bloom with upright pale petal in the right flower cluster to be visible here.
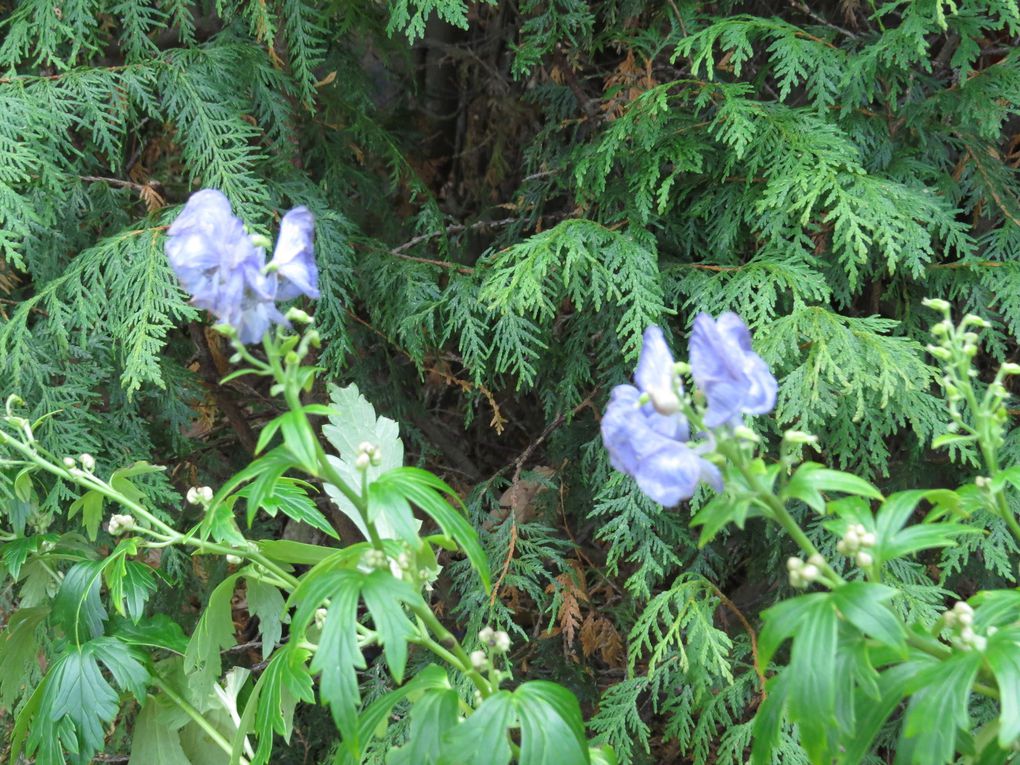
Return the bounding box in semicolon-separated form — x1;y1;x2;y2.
602;326;722;507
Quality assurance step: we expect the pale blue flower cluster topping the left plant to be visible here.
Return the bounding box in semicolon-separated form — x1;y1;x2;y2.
166;189;319;344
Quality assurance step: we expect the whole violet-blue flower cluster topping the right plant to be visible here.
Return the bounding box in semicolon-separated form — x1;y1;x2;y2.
602;313;777;506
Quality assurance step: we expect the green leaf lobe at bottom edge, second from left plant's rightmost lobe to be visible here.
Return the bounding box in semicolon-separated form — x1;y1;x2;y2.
439;691;518;765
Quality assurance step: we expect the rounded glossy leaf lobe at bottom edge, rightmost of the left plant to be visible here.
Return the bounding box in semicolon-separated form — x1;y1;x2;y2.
513;680;590;765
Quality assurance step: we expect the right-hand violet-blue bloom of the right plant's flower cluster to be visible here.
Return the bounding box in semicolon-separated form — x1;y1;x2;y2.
690;313;778;427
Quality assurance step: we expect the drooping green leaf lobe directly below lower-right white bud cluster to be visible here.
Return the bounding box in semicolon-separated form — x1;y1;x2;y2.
897;651;982;765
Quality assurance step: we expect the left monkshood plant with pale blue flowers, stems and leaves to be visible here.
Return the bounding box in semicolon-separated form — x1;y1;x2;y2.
0;190;615;765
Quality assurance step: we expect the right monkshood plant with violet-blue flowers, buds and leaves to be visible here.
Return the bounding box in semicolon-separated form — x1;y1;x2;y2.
602;300;1020;765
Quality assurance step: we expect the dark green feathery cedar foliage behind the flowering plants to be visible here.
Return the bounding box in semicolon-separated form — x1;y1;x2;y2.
0;0;1020;763
